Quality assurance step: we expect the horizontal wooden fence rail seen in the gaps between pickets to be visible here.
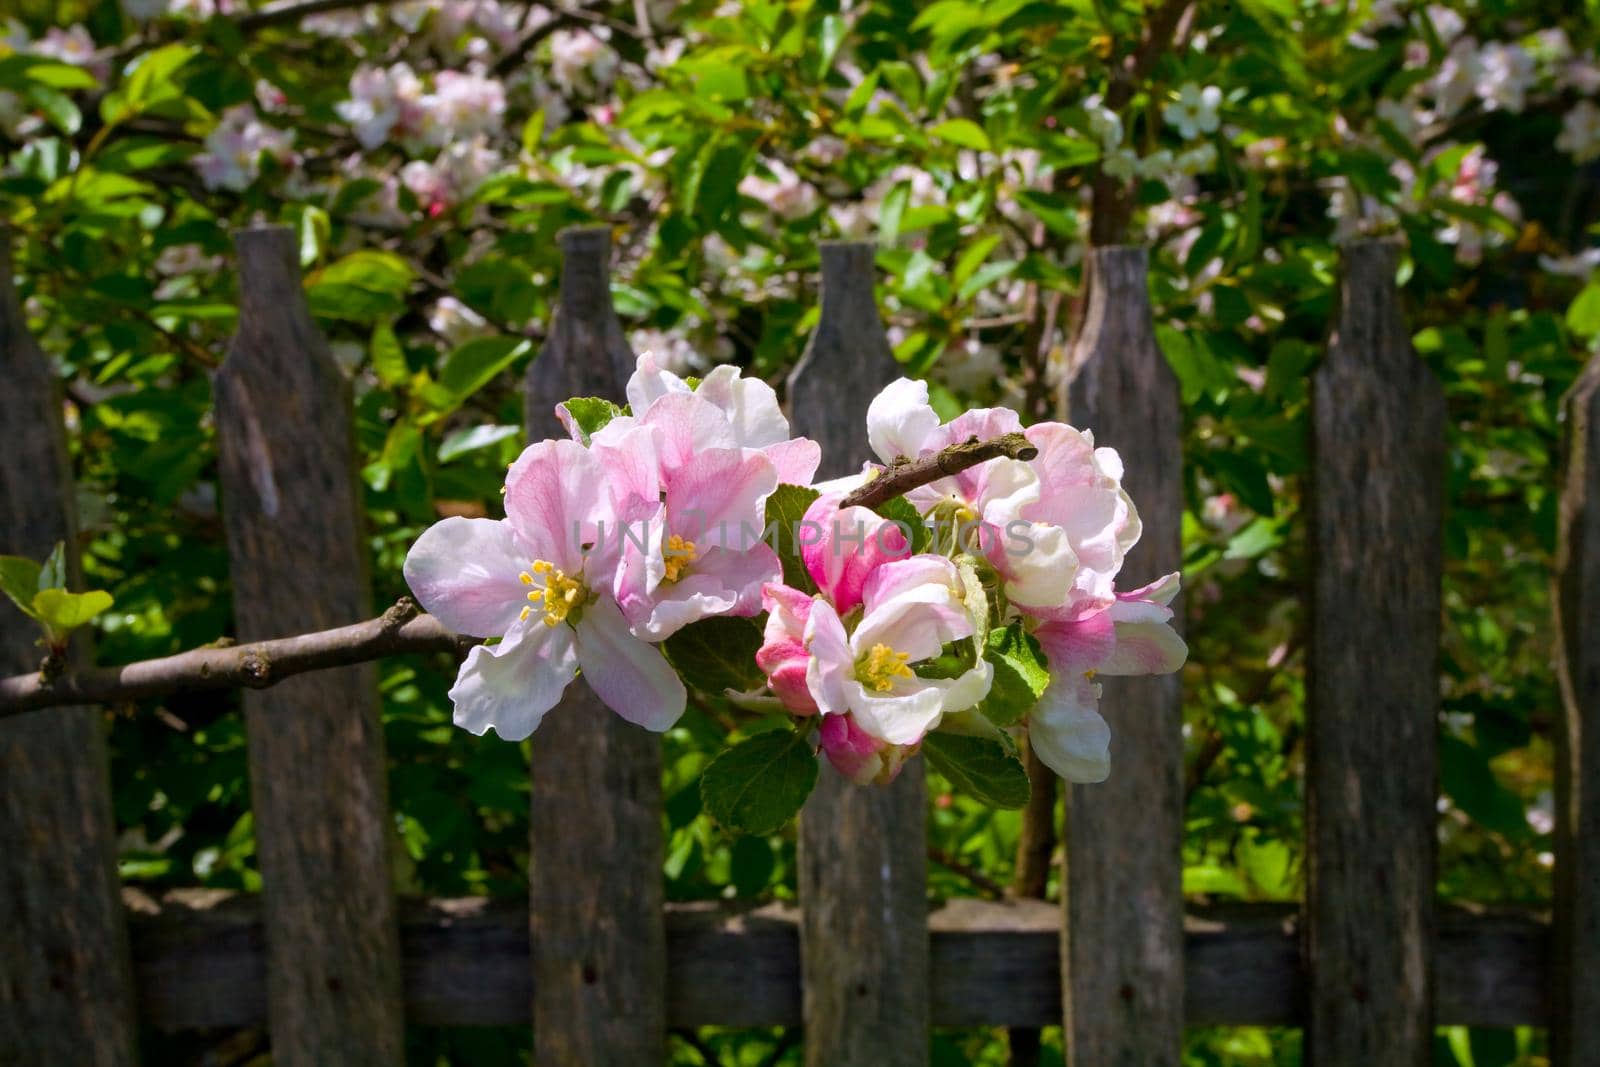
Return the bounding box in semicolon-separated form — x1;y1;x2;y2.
123;889;1550;1036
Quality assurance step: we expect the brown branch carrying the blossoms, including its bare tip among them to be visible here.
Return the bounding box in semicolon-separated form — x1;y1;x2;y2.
0;434;1035;718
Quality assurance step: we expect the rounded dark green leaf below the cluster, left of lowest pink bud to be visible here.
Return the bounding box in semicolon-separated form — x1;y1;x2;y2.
701;729;819;835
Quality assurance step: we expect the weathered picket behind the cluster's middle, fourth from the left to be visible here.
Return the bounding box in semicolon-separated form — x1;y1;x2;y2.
789;242;930;1067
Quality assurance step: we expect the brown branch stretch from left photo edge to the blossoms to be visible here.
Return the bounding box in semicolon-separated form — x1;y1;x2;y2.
0;598;478;718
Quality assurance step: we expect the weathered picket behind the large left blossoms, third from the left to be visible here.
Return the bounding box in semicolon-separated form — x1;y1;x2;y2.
526;229;667;1067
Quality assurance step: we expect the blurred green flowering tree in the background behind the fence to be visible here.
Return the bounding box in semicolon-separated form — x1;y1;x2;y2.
0;0;1600;1065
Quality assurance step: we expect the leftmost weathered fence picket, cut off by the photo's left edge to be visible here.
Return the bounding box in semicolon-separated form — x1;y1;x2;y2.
0;227;136;1064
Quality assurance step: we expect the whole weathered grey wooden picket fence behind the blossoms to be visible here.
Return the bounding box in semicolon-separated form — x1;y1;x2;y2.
0;229;1600;1067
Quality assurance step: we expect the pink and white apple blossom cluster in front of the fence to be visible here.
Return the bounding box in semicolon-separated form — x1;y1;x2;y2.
405;354;1187;793
